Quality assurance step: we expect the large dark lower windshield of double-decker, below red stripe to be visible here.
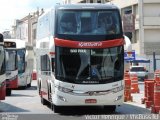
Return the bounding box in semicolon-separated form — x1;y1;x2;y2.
56;46;124;84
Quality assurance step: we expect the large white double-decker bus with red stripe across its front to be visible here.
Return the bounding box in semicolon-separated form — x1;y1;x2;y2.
36;4;124;112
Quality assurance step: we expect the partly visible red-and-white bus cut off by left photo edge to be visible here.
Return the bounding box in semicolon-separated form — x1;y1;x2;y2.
0;34;6;100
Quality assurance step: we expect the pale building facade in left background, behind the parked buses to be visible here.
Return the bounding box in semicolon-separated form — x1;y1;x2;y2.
12;9;44;46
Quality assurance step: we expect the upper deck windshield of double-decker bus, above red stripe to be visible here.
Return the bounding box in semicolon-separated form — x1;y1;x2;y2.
57;10;122;37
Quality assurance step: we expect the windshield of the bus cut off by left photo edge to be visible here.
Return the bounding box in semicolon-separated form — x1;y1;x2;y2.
0;45;5;75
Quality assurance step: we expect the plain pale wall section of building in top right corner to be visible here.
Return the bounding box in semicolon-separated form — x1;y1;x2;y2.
142;0;160;55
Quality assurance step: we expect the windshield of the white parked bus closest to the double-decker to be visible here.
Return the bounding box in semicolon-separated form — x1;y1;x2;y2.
17;49;26;73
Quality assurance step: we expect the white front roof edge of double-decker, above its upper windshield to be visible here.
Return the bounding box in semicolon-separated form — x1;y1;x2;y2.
55;3;118;10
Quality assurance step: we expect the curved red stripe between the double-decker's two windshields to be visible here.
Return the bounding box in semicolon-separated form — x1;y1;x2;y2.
54;38;125;48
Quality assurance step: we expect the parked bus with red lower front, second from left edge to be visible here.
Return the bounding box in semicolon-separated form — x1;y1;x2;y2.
4;39;18;96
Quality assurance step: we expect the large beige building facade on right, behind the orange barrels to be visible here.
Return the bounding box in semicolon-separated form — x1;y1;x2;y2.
112;0;160;72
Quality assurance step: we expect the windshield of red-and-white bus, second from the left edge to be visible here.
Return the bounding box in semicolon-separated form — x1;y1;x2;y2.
6;50;17;71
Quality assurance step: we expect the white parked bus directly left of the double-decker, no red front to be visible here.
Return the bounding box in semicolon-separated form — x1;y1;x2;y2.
15;39;34;87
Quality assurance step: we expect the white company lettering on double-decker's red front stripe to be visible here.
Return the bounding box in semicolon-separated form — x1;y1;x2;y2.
78;42;102;47
